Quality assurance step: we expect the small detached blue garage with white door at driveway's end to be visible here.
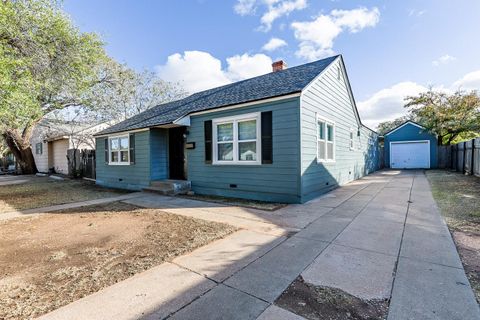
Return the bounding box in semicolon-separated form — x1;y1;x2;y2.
384;121;437;169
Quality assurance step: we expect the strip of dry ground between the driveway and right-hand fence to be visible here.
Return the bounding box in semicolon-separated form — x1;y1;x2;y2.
426;170;480;303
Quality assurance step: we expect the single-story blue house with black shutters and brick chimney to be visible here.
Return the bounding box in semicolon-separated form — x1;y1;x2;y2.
96;56;379;203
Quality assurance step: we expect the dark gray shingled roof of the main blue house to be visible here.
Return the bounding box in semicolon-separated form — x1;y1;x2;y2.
97;56;338;135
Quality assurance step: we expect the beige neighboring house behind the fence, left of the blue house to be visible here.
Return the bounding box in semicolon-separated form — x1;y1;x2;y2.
30;119;109;174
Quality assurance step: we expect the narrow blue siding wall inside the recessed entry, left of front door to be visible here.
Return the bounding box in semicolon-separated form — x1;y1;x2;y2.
150;128;168;180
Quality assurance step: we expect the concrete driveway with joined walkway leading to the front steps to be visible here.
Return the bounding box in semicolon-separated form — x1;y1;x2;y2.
42;171;480;320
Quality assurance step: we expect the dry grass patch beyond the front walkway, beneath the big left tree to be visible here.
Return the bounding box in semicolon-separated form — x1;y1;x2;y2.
0;177;126;214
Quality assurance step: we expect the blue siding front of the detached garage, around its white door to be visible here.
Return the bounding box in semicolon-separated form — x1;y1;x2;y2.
384;123;438;168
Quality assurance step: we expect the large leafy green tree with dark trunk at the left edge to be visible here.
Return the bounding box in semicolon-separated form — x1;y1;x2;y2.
0;0;108;173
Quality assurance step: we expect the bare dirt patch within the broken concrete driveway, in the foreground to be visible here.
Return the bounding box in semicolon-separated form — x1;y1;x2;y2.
275;277;388;320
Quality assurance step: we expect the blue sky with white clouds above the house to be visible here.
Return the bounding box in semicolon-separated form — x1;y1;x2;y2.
64;0;480;126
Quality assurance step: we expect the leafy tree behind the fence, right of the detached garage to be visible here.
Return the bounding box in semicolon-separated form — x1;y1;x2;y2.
405;89;480;145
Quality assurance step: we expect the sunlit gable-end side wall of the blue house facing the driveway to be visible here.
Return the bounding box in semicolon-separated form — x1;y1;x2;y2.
300;59;379;202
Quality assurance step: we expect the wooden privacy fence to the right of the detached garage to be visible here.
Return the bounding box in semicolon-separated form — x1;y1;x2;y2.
438;138;480;177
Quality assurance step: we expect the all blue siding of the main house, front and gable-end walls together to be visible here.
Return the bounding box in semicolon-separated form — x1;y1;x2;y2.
97;59;379;203
